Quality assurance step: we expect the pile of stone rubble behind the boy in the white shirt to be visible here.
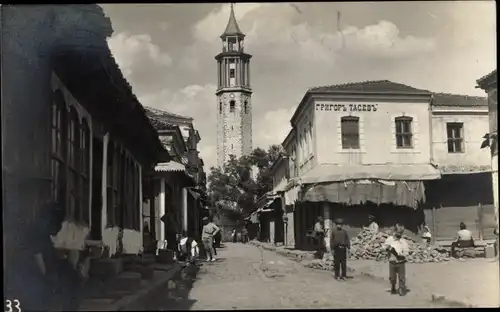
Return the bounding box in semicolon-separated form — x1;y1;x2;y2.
350;229;451;263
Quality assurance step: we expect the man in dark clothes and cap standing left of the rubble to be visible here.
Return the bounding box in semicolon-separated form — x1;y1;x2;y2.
330;219;351;280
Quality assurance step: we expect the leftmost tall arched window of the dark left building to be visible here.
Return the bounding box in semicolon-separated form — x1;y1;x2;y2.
51;91;66;203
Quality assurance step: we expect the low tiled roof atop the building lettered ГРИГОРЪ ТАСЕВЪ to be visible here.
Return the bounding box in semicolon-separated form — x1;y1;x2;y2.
308;80;430;93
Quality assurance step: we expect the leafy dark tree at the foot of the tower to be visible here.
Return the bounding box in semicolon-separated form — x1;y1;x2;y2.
208;145;283;221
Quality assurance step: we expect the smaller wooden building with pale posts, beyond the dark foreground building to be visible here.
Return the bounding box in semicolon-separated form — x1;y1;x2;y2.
144;108;208;249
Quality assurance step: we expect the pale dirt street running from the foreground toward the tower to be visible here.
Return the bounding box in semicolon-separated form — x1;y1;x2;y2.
168;243;454;310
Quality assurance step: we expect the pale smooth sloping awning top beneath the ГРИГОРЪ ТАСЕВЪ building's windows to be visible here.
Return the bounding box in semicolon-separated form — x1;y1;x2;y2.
300;164;441;184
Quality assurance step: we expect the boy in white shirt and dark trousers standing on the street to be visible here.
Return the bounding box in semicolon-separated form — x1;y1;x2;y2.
384;226;410;296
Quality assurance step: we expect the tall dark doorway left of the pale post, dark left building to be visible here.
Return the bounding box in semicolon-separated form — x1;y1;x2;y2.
90;137;103;240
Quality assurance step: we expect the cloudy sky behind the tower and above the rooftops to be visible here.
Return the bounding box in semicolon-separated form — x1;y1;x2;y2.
101;1;497;169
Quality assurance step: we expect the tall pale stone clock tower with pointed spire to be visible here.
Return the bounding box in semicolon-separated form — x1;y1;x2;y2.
215;4;252;167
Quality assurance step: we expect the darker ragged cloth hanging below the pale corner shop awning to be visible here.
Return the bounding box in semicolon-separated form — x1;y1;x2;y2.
301;180;425;209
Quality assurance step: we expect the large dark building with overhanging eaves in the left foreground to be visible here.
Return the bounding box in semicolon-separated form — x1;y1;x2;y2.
1;5;171;286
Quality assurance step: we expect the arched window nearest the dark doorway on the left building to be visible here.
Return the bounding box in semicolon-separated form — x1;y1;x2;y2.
80;119;90;223
